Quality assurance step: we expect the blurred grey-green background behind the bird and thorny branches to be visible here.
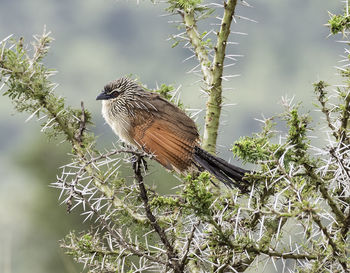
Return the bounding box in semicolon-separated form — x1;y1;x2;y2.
0;0;343;273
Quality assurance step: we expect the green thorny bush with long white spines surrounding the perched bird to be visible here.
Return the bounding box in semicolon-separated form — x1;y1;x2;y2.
0;0;350;272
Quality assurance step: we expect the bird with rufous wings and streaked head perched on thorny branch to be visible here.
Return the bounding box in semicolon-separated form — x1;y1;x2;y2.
96;77;249;191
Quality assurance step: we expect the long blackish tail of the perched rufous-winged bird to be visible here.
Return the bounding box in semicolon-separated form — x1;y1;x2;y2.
194;146;250;191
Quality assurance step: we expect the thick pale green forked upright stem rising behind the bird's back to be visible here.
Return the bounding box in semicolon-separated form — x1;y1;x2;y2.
177;0;237;154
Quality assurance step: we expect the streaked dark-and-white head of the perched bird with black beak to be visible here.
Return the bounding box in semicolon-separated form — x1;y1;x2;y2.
96;77;140;100
